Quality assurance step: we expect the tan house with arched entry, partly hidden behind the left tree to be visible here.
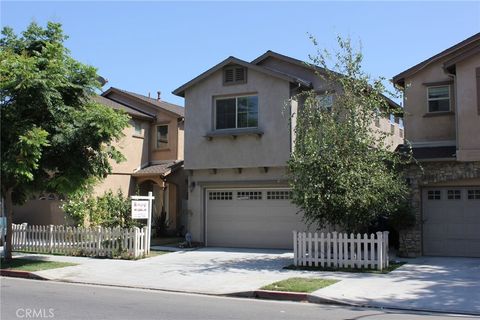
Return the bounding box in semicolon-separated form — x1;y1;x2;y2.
14;88;186;232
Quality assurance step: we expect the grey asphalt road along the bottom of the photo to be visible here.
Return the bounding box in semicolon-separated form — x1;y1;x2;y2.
0;277;476;320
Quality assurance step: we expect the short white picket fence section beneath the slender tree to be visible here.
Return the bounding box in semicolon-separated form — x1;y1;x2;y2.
293;231;388;270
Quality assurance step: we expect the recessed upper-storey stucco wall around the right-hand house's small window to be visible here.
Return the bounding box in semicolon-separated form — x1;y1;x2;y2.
404;62;456;143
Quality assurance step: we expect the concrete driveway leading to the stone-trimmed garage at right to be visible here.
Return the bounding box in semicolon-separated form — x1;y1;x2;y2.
314;257;480;315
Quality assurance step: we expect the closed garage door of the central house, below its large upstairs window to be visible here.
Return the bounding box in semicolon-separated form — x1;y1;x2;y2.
206;189;305;249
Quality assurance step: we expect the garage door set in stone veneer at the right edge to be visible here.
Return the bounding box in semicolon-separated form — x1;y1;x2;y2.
422;187;480;257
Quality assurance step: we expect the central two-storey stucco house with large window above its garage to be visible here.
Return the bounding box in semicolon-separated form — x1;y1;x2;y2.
173;51;403;248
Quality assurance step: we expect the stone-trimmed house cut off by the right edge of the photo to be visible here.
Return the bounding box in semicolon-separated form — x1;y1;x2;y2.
393;33;480;257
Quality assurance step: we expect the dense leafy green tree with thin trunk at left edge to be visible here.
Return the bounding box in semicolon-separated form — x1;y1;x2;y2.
0;22;129;259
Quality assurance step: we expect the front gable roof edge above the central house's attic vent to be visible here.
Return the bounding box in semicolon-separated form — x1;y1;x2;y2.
173;57;311;97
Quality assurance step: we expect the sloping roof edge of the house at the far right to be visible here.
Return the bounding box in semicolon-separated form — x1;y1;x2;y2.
392;32;480;87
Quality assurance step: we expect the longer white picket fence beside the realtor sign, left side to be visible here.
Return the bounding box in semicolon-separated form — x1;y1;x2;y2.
12;223;150;258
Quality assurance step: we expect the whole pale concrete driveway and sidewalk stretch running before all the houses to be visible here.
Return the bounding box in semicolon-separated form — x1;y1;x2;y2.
16;248;480;315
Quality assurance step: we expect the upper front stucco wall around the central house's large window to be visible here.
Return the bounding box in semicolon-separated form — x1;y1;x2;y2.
185;69;290;169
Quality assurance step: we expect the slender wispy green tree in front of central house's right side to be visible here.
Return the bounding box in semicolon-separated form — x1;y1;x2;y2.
288;37;408;232
